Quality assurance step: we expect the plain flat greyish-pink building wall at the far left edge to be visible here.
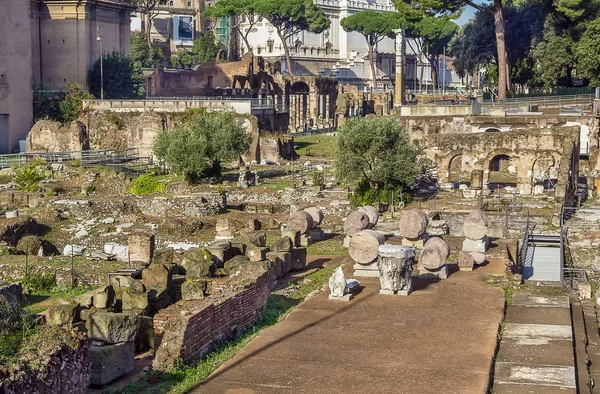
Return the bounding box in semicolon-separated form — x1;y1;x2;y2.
0;0;33;153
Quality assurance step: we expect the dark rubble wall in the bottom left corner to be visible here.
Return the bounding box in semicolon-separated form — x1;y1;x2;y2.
0;332;90;394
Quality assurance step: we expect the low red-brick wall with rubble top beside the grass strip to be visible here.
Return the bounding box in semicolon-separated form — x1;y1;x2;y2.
152;272;270;371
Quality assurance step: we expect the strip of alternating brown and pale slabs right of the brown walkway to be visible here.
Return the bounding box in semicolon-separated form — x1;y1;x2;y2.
494;294;577;394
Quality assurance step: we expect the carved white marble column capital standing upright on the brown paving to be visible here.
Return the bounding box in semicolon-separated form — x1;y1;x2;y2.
377;245;415;295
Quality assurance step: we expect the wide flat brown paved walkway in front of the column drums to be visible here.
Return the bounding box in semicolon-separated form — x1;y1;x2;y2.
193;261;504;394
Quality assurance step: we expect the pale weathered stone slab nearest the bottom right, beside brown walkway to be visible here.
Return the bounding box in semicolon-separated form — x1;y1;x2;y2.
494;362;577;394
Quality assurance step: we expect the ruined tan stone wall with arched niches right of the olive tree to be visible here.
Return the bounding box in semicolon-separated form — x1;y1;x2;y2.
421;127;580;202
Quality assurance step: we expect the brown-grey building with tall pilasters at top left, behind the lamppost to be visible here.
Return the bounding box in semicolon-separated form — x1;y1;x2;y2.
30;0;135;89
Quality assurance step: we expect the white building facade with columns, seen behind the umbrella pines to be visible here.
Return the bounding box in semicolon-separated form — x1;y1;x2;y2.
239;0;460;90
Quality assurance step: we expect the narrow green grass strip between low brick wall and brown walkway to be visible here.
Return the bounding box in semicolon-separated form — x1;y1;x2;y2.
103;266;337;394
